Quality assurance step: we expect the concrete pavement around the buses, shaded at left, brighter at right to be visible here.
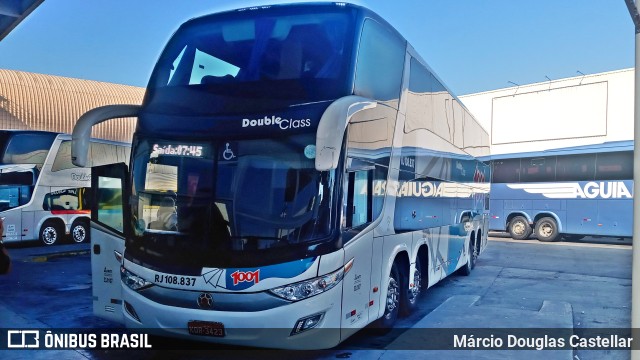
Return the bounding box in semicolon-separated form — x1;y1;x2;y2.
0;241;630;360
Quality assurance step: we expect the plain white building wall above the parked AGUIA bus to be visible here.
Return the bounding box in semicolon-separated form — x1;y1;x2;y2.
460;68;634;155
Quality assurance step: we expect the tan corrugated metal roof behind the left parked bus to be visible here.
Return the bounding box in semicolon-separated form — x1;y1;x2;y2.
0;69;145;141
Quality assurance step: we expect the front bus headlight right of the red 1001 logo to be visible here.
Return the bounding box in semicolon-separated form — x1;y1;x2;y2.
269;259;353;301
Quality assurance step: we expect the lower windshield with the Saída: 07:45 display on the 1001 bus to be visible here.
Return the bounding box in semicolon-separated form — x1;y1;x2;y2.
128;134;335;267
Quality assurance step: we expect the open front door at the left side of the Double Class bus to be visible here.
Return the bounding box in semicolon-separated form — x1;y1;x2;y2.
91;163;128;323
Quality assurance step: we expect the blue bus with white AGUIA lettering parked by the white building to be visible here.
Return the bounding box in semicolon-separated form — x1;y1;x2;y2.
489;141;633;241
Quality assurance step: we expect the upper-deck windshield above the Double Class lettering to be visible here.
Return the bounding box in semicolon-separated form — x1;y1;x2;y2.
147;9;354;114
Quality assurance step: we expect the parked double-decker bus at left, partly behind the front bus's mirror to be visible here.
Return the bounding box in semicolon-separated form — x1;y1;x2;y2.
0;130;131;245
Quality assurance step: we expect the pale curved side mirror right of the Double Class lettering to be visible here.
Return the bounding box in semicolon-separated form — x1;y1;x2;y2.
315;95;377;171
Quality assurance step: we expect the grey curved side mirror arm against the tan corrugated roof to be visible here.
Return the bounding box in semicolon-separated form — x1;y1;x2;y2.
71;105;141;167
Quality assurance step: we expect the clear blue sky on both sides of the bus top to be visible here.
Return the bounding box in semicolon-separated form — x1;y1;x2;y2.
0;0;635;95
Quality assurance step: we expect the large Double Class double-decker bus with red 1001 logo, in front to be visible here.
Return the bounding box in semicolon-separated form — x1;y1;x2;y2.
73;3;489;349
